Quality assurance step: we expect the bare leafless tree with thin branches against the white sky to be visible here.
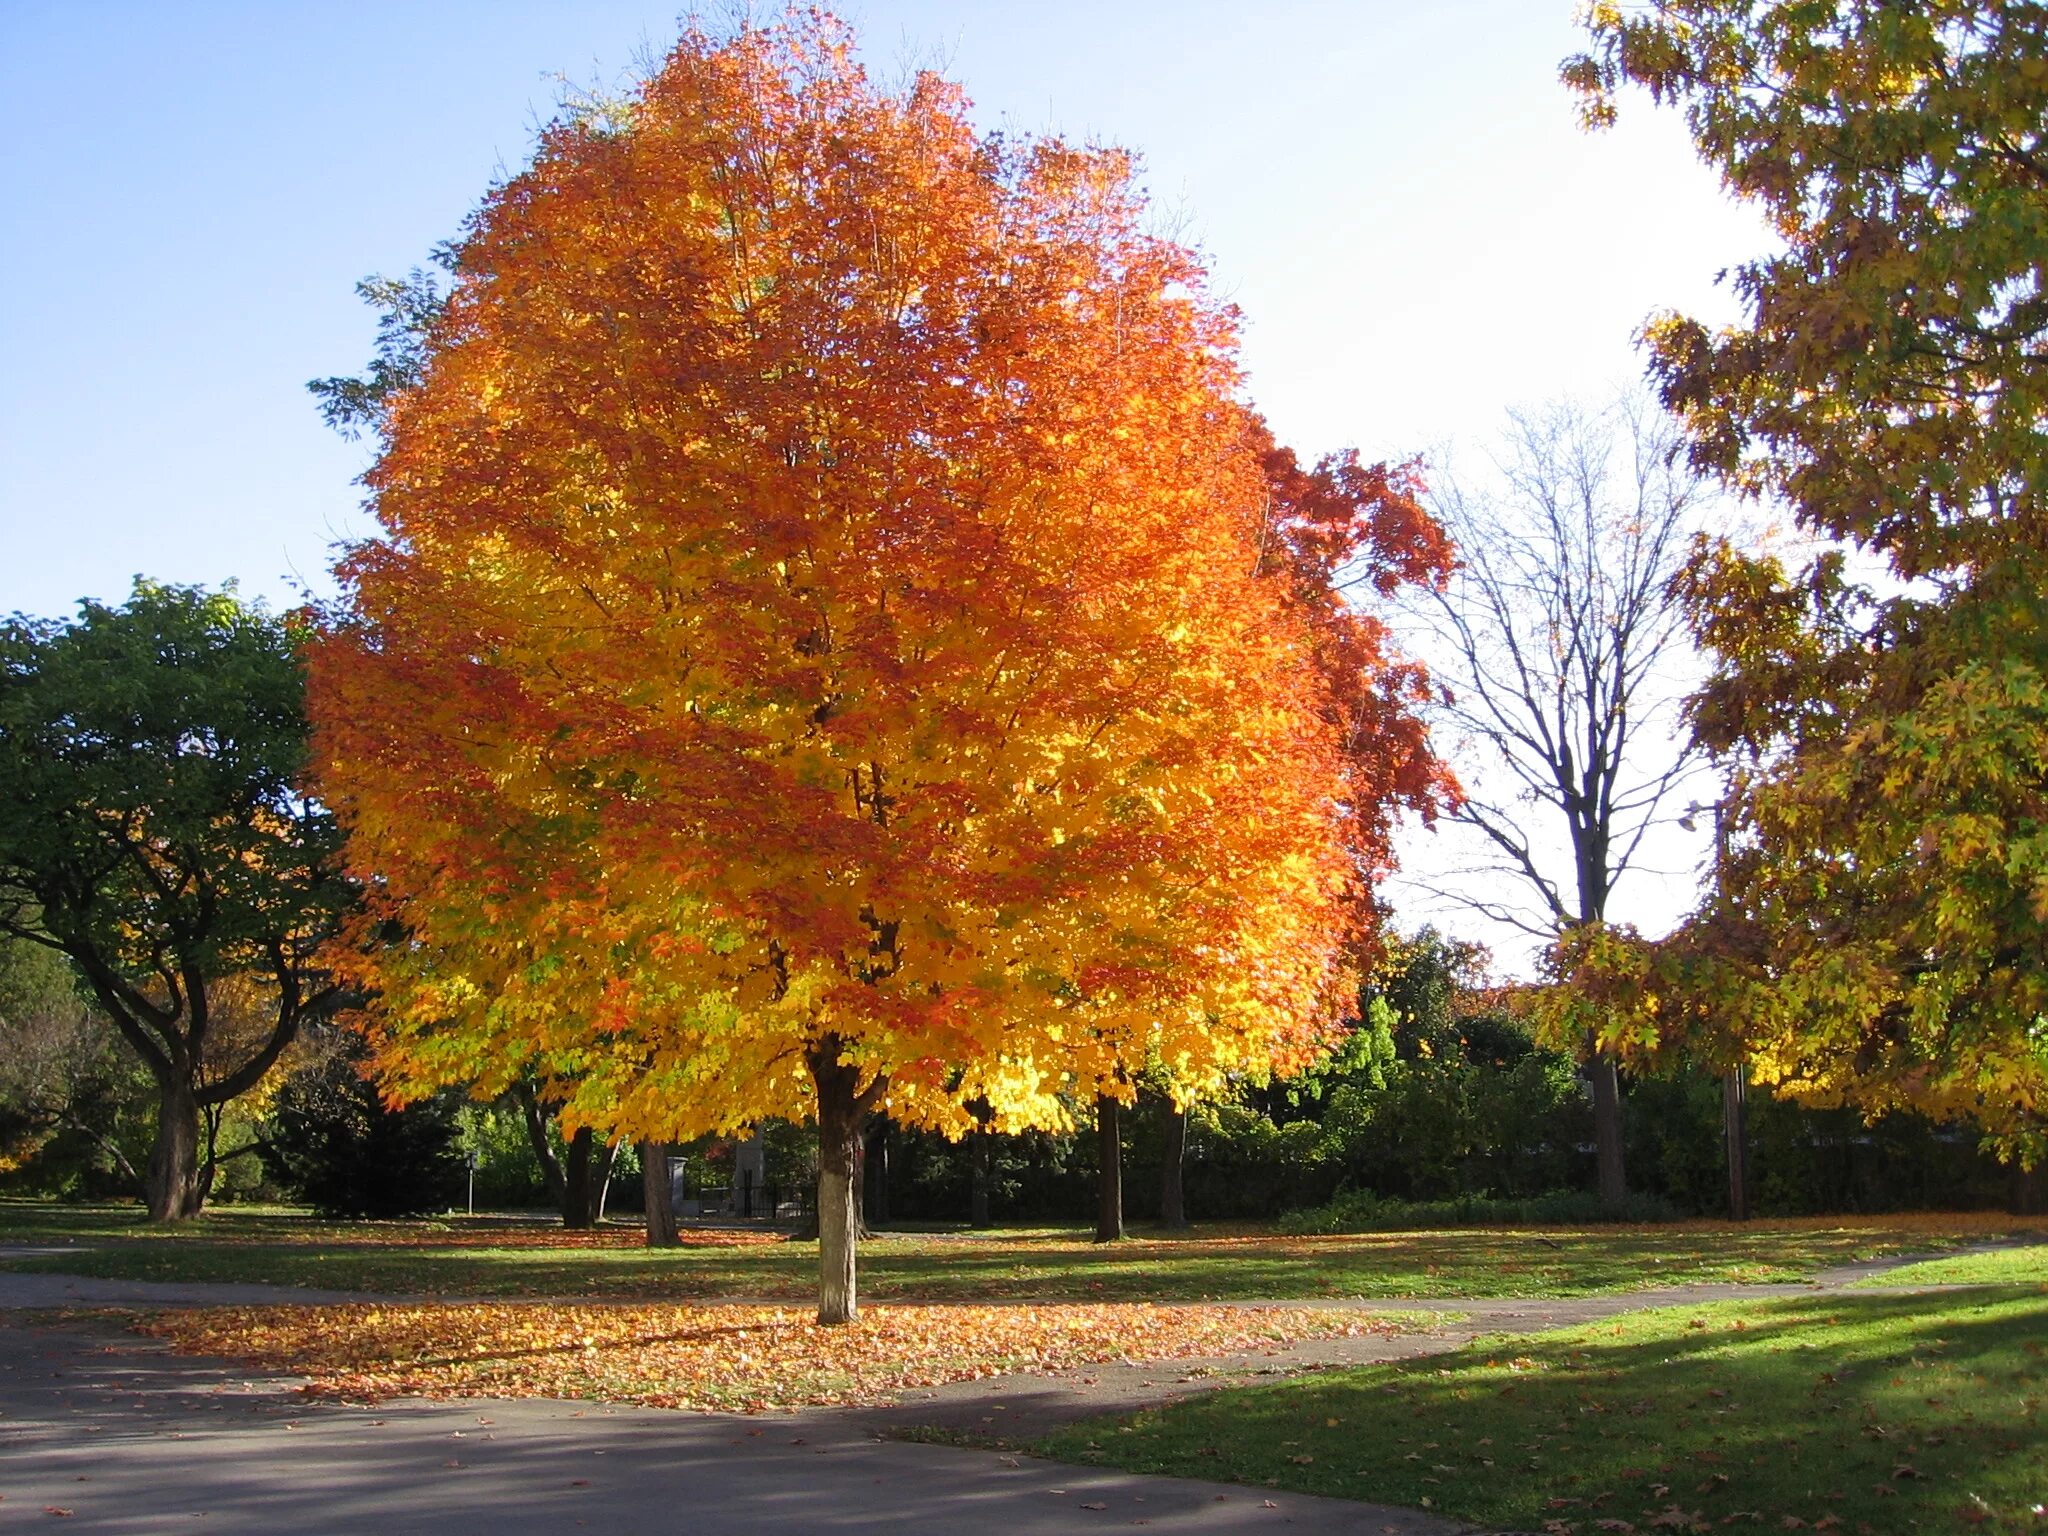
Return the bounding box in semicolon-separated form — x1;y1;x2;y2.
1421;397;1712;1206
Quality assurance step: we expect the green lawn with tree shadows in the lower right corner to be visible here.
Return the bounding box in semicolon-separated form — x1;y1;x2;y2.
1034;1286;2048;1536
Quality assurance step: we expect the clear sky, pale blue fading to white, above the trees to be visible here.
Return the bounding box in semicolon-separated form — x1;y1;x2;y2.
0;0;1765;974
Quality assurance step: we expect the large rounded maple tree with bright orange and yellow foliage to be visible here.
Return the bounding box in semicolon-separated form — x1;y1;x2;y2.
313;18;1448;1321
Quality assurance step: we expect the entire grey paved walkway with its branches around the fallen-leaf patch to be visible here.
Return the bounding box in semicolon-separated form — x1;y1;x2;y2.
0;1260;2015;1536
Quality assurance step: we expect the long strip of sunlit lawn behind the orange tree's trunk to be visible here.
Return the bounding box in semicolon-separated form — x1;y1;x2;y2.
0;1202;2015;1300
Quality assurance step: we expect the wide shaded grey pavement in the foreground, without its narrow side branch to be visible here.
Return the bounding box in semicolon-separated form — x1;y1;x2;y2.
0;1315;1462;1536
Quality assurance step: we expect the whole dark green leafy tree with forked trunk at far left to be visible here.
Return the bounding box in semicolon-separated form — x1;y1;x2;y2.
0;582;352;1221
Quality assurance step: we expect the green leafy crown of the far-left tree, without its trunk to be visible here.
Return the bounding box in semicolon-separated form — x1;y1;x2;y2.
0;582;346;985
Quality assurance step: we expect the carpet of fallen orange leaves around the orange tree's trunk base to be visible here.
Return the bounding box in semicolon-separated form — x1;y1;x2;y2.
135;1303;1400;1413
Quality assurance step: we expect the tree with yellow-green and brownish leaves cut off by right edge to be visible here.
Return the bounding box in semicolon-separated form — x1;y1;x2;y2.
1567;0;2048;1157
